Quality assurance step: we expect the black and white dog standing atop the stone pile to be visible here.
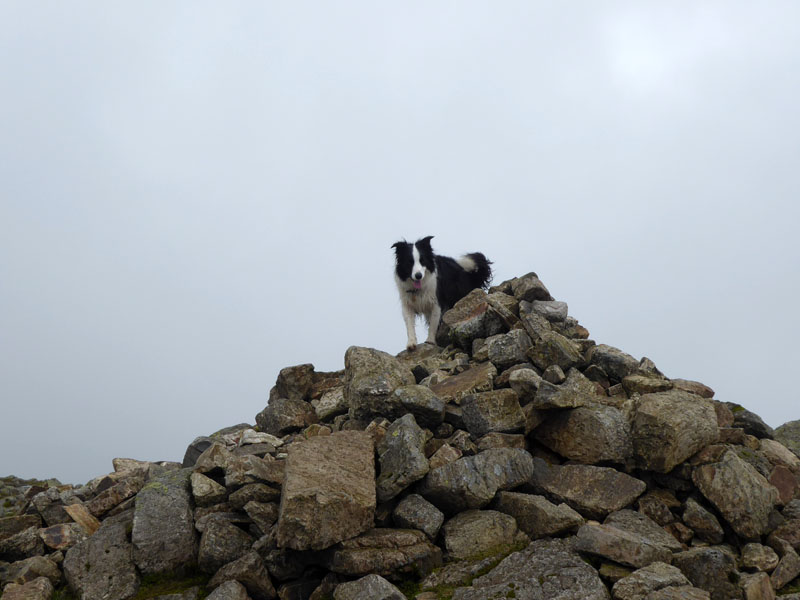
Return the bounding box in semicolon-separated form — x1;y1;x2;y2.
392;235;492;350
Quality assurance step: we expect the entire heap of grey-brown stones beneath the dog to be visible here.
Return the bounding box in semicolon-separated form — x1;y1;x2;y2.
0;273;800;600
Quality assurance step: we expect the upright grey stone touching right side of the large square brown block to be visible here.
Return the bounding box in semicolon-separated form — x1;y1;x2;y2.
375;414;429;502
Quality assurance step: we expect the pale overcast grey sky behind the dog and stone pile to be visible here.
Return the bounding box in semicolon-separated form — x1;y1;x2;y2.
0;0;800;483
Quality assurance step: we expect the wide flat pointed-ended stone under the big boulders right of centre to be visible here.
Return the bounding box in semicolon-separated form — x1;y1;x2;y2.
530;458;647;519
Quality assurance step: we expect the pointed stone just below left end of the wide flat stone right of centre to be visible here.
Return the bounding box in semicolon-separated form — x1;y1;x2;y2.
492;492;584;540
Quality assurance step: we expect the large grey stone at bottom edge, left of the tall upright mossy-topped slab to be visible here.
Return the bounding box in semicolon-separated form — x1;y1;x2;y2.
63;521;139;600
